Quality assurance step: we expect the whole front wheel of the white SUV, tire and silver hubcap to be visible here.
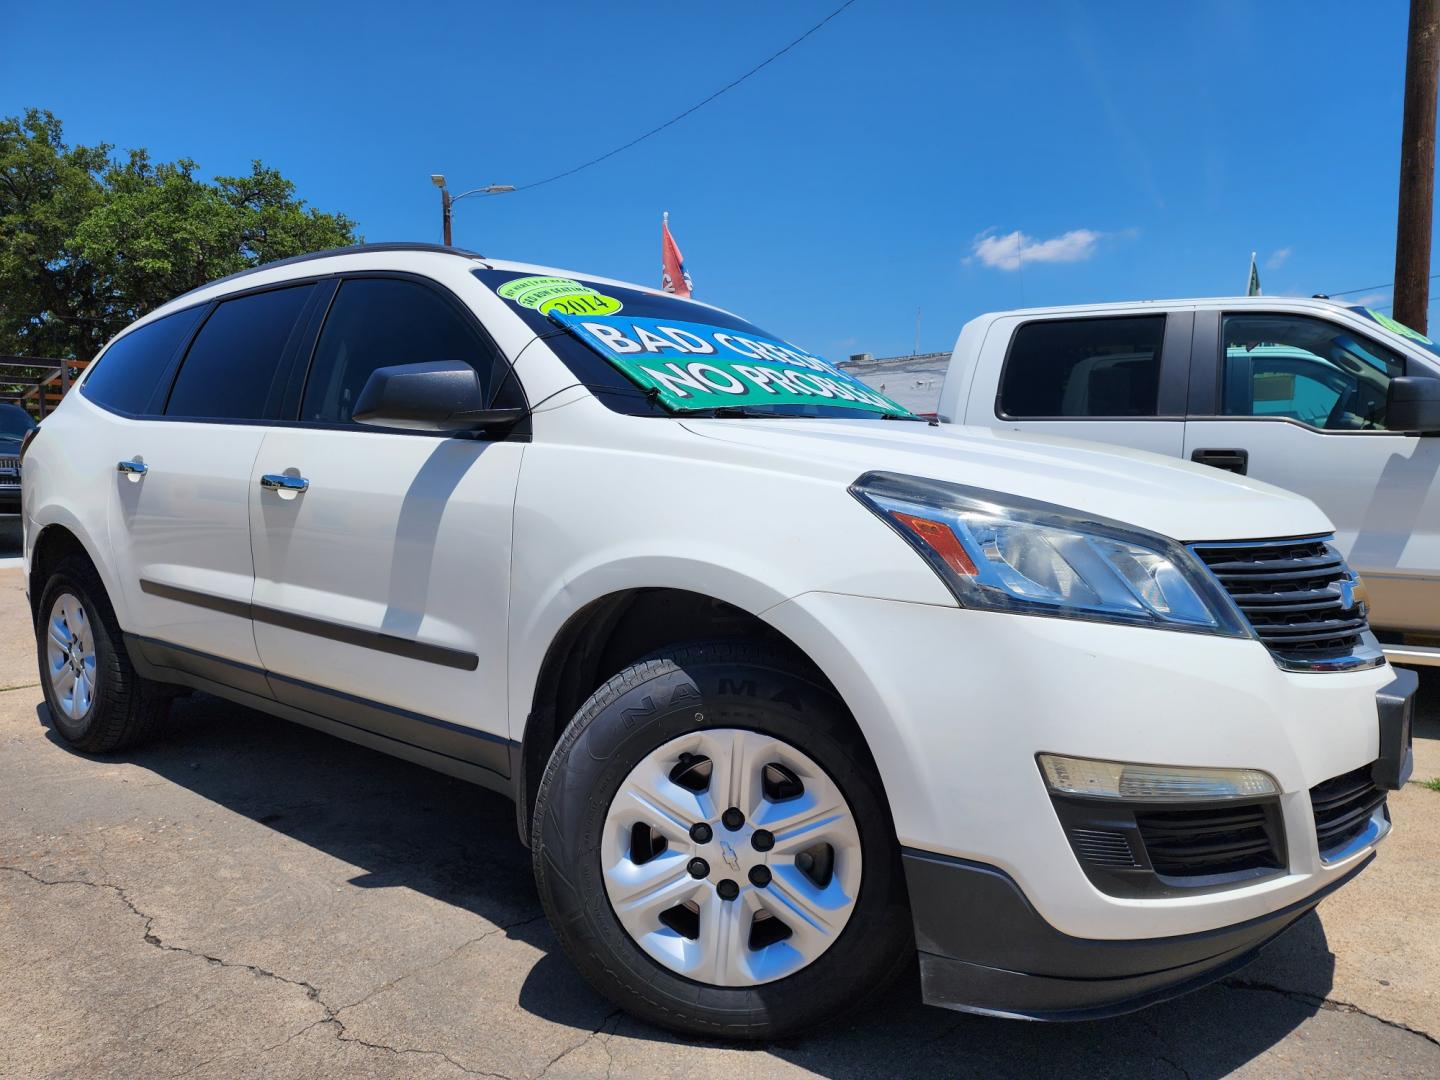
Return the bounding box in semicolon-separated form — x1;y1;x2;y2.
533;644;910;1038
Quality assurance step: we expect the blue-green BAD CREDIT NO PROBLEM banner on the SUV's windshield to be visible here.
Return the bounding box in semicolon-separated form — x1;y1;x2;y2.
547;312;907;416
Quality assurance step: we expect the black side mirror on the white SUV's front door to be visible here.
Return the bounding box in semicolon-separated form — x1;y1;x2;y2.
353;360;524;432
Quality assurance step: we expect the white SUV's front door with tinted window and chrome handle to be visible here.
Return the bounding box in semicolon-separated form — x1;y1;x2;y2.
249;274;524;776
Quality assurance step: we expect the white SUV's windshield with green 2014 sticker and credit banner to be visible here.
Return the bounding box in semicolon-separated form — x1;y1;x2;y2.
471;269;910;419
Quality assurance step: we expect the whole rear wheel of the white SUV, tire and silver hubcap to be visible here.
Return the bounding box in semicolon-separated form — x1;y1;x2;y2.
35;556;170;753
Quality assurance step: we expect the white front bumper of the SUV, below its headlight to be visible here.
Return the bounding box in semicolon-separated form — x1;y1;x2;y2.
765;593;1394;973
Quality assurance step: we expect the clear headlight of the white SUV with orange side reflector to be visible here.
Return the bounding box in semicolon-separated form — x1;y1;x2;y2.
850;472;1250;638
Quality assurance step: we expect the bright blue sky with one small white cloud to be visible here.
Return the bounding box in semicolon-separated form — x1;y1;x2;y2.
0;0;1407;359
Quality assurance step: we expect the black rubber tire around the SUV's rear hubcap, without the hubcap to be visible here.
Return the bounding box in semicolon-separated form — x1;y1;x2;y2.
35;556;170;753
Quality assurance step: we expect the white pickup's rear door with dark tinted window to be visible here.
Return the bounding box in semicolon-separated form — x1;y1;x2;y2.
967;310;1194;458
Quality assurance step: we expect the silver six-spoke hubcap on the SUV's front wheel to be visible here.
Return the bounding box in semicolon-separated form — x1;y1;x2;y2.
600;729;861;986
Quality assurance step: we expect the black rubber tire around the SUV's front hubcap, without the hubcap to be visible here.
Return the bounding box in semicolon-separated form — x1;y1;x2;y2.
531;642;913;1040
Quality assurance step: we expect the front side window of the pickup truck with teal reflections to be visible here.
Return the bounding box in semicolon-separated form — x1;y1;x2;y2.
1221;314;1405;431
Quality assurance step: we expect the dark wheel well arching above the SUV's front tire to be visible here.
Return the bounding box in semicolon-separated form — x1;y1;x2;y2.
516;589;840;847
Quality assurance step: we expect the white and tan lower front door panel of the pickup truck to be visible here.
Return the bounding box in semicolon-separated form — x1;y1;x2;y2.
1185;419;1440;629
